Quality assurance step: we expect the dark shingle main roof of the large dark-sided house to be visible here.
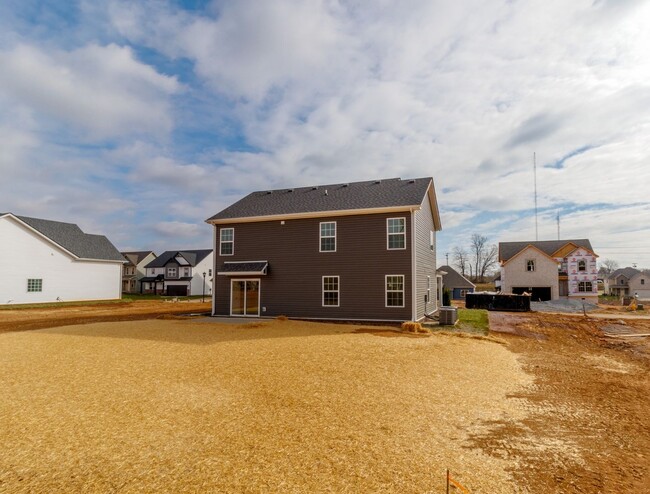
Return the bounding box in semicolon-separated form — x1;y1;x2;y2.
207;177;433;222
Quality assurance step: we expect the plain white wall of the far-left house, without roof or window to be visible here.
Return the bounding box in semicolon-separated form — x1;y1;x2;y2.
0;217;122;304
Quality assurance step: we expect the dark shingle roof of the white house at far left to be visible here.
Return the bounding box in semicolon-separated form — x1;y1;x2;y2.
16;216;124;261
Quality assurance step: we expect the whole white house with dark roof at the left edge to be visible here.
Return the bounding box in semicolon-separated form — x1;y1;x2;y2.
0;213;124;304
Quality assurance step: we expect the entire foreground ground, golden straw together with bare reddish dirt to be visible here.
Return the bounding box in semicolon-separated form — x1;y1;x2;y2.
0;307;650;493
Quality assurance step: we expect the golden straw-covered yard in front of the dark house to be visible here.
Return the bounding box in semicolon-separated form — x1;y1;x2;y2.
0;320;532;493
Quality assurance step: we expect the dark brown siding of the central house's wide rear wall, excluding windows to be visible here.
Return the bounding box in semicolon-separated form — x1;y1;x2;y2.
215;212;412;321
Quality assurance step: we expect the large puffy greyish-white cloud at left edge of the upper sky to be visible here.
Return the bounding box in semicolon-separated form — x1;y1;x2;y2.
0;44;180;138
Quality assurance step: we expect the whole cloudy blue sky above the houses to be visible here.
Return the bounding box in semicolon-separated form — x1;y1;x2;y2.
0;0;650;267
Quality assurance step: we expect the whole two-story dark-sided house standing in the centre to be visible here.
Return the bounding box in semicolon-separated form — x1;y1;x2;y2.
206;178;441;321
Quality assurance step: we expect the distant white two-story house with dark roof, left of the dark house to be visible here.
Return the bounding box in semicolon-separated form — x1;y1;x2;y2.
140;249;213;296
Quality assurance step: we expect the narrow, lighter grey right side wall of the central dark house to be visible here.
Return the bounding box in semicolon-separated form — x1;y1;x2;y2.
415;191;437;320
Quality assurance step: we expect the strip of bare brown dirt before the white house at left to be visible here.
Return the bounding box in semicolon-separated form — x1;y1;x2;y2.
0;299;210;333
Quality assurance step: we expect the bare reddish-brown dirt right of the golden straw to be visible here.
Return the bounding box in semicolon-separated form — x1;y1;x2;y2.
484;312;650;493
